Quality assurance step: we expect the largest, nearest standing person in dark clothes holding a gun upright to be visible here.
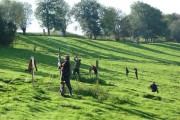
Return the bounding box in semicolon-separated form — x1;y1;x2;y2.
60;55;72;97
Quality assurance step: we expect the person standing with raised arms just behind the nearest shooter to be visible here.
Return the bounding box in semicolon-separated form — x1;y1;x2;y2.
73;56;81;78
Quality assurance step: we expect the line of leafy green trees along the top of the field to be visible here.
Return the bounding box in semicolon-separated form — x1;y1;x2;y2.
0;0;180;45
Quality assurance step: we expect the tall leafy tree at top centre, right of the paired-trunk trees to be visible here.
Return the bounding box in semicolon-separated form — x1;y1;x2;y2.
72;0;101;39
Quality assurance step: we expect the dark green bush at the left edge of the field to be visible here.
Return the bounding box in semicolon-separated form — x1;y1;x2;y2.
0;17;16;46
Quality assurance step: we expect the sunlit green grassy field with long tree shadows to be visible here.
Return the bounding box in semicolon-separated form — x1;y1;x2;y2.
0;35;180;120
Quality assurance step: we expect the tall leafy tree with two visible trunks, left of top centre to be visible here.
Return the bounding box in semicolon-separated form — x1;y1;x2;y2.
35;0;70;35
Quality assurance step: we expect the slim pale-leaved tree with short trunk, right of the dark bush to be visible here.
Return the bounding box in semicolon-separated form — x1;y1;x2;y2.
20;2;33;35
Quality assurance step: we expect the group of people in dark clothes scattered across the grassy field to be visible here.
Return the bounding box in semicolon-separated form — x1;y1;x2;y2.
25;55;159;97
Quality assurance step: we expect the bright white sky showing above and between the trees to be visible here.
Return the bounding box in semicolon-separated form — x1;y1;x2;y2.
16;0;180;35
